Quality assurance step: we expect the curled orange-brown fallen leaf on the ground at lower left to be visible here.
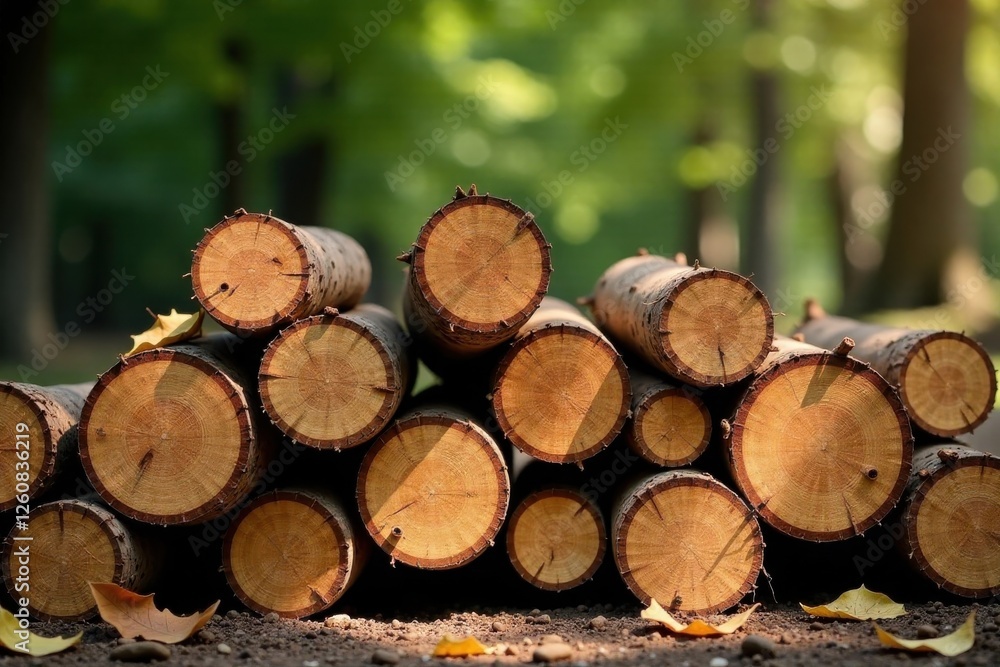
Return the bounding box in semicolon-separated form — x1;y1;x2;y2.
90;583;219;644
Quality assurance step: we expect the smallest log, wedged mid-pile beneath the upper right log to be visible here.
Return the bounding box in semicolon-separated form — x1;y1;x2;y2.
625;368;712;468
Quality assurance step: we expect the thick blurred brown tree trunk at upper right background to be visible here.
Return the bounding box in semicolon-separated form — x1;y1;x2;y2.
867;0;972;310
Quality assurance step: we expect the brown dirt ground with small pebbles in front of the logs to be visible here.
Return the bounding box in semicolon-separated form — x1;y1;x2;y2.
13;602;1000;667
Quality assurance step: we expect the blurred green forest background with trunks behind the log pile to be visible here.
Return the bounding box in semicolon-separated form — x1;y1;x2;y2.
0;0;1000;383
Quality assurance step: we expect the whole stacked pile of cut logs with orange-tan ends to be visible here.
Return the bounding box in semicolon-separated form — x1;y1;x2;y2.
0;186;1000;620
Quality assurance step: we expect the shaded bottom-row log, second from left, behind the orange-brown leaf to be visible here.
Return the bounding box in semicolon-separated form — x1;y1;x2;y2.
222;489;368;618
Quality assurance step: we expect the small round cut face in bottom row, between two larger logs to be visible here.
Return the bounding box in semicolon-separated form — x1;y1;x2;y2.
507;489;607;591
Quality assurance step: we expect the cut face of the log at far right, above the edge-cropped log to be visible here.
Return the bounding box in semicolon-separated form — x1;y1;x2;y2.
899;331;997;437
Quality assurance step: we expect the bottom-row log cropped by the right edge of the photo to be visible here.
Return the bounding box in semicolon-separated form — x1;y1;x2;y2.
902;443;1000;598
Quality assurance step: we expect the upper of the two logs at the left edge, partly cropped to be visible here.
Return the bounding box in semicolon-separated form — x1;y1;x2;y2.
0;382;94;512
